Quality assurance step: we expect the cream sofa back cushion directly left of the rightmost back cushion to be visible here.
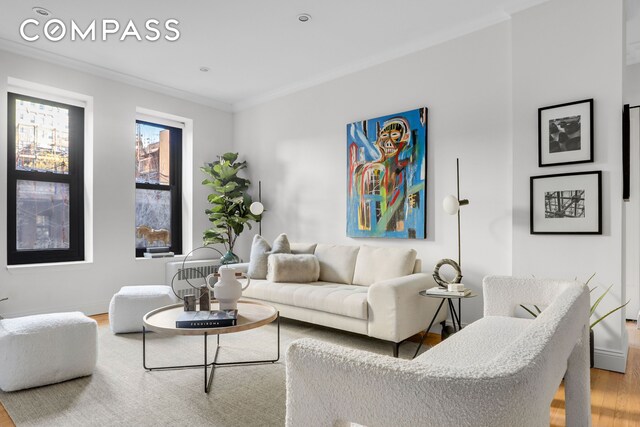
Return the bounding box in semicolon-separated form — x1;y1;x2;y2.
315;243;360;285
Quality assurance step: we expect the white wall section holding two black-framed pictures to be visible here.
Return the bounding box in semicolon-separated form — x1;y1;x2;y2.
512;0;627;371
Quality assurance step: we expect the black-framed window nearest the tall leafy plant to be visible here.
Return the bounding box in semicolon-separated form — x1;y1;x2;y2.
136;120;182;257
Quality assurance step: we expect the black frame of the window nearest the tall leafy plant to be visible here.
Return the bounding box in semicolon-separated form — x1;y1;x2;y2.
134;117;184;258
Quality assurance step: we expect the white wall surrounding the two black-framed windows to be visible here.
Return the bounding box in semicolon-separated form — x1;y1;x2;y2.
0;51;232;316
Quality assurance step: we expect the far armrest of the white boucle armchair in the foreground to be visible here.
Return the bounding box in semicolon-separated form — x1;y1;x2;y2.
482;276;576;317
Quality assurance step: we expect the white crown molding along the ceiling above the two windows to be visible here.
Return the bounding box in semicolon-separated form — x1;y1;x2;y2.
0;38;232;112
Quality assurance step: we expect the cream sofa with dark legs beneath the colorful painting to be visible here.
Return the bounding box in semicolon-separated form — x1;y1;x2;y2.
234;243;447;356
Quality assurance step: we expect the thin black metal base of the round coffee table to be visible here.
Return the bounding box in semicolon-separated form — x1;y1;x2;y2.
142;313;280;393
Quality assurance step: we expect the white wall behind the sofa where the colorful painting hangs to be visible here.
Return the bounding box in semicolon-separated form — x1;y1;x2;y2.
234;23;512;328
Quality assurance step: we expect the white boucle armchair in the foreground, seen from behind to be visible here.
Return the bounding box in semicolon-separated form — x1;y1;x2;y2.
286;277;591;427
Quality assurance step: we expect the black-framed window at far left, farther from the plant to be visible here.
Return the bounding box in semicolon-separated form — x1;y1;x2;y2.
7;93;84;265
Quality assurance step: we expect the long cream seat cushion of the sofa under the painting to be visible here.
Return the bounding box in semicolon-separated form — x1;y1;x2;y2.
242;280;368;320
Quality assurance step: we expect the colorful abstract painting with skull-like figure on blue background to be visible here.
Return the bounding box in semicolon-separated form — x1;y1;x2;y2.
347;108;427;239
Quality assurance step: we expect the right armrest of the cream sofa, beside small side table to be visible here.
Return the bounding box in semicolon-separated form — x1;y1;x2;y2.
367;273;447;342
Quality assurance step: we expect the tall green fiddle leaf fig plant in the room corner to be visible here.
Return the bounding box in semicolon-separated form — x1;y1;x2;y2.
200;153;260;262
